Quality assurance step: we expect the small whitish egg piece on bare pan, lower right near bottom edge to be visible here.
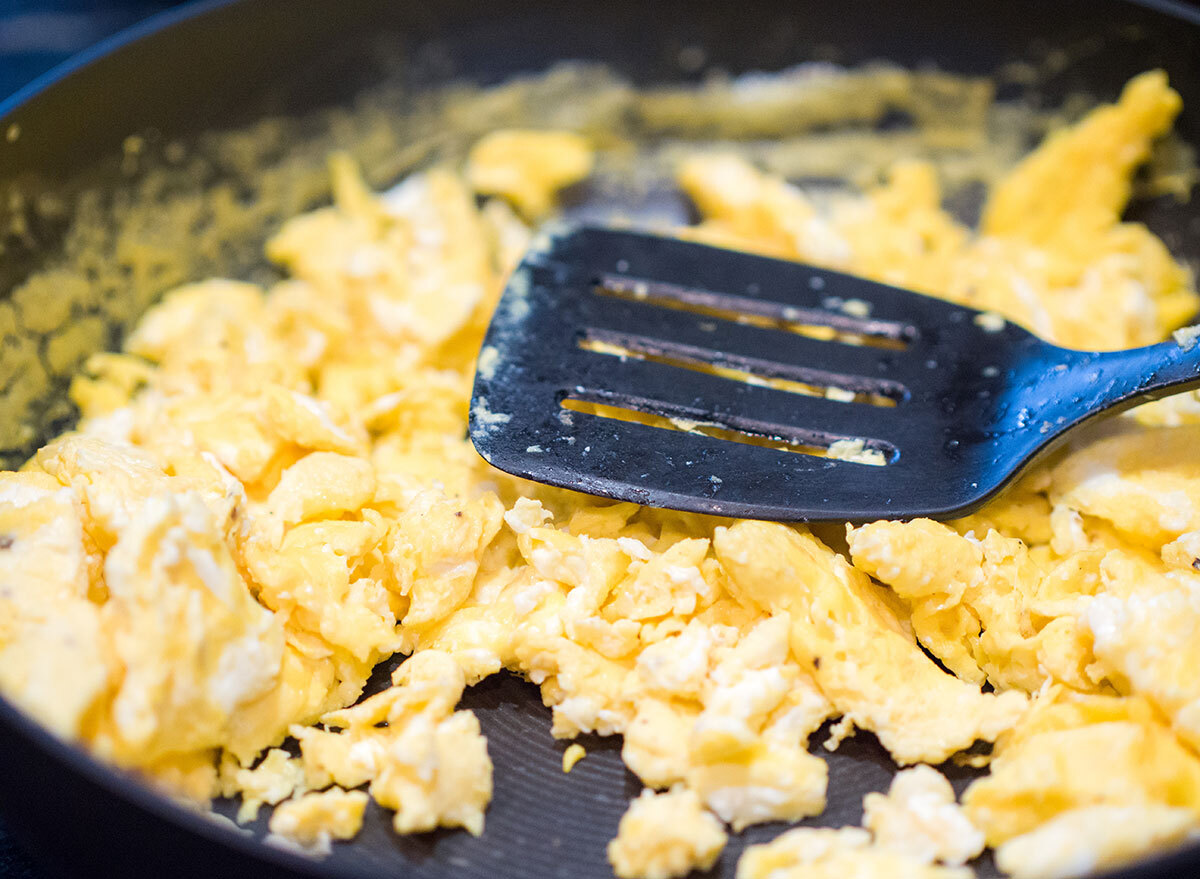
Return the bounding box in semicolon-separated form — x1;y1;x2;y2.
863;766;984;866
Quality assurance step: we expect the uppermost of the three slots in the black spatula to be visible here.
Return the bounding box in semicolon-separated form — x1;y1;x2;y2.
593;275;916;351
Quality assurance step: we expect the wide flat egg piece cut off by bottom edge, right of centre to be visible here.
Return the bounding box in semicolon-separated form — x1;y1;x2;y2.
737;827;973;879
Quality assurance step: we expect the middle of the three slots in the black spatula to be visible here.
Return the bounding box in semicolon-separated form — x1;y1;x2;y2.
578;329;905;408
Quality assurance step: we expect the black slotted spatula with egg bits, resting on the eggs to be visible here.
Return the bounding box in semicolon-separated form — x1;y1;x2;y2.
470;227;1200;521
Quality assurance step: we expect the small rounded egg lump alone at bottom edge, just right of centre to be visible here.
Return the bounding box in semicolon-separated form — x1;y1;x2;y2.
608;788;726;879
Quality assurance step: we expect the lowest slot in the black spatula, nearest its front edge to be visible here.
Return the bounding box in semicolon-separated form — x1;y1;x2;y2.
559;393;898;467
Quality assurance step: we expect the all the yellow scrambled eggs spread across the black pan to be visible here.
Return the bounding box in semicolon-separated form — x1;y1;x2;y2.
0;63;1200;879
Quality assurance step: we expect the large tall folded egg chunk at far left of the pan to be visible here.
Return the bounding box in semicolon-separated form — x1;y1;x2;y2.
30;436;286;779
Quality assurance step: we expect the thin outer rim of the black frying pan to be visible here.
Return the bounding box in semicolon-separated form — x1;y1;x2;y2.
0;0;1200;879
